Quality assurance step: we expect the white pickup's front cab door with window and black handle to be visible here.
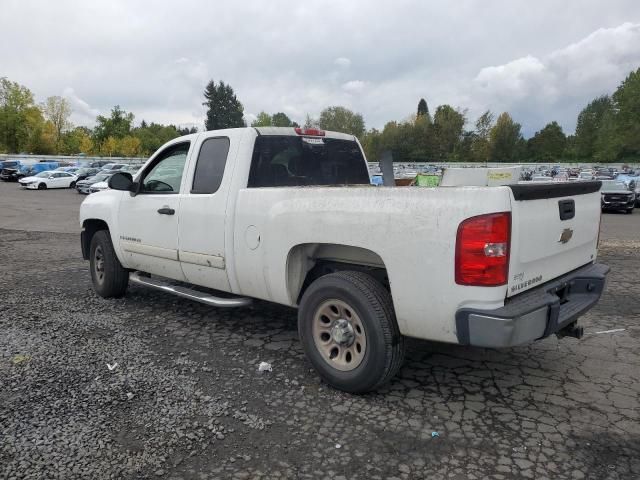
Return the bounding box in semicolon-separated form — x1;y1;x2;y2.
117;141;192;280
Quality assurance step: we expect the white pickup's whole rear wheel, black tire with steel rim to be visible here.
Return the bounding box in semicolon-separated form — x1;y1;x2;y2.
298;271;404;393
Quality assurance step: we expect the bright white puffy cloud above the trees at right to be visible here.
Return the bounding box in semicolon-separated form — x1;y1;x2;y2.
471;22;640;131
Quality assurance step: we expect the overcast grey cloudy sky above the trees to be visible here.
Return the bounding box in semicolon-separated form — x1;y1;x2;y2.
0;0;640;136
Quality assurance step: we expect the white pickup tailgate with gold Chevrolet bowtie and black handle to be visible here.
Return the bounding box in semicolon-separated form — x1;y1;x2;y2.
507;182;601;297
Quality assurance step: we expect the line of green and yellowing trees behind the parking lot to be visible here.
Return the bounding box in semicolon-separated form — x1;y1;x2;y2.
0;69;640;163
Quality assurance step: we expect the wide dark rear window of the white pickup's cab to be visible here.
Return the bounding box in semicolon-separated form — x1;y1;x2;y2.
248;136;369;188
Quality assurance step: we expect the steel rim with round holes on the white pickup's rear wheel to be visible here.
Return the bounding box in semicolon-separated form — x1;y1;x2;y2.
312;299;367;372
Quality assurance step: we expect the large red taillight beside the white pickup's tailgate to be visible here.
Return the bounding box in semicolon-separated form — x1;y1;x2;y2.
455;212;511;287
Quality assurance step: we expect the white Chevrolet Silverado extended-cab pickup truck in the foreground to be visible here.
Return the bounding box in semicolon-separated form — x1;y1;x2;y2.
80;127;609;392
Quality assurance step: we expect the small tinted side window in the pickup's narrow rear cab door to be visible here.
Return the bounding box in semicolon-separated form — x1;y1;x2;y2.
191;137;229;193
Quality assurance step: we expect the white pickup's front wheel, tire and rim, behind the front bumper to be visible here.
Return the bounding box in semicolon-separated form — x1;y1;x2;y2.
89;230;129;298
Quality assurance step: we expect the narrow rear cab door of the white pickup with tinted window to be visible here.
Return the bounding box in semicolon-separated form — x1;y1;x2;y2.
178;132;240;291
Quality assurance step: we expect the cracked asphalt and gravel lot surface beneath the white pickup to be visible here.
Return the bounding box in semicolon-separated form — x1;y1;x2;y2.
0;182;640;479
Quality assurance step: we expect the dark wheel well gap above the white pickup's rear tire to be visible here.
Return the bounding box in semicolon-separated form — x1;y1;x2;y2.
287;243;390;304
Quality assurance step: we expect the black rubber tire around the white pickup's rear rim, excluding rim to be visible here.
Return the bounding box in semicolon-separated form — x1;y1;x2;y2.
298;271;405;393
